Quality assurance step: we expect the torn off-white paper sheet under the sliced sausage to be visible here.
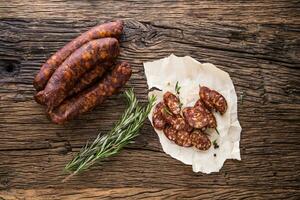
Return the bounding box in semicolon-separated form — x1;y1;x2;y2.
144;54;242;173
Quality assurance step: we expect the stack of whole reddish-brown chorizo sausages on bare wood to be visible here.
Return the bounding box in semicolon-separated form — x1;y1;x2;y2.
33;21;131;124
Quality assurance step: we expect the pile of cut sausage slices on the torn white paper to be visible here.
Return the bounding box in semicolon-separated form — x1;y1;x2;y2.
152;86;227;151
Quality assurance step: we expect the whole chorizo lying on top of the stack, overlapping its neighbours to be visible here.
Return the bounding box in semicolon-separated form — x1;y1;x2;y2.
35;38;120;111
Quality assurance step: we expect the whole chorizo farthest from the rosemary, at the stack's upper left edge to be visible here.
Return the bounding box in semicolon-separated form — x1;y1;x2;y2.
33;20;123;91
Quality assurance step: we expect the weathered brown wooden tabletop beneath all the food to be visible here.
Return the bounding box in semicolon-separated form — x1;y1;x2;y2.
0;0;300;200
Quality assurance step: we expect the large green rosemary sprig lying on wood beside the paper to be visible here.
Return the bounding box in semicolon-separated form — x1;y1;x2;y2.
65;89;156;181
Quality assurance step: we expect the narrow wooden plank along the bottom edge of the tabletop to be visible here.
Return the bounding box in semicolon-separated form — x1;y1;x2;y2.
3;187;299;200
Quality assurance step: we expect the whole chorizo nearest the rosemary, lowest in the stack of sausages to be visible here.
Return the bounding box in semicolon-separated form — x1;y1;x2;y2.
48;62;131;124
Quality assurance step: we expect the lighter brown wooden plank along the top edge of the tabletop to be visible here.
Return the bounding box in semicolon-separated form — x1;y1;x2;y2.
0;0;300;24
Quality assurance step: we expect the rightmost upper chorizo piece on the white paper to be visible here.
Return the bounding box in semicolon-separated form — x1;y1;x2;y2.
199;86;227;115
